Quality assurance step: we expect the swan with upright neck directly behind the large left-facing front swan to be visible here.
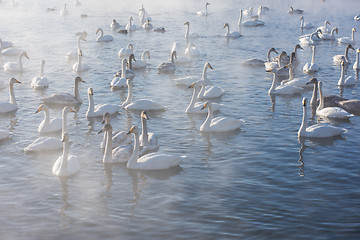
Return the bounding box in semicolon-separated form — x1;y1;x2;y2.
139;111;159;156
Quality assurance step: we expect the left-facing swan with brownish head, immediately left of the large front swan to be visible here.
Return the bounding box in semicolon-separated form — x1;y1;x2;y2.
98;123;133;163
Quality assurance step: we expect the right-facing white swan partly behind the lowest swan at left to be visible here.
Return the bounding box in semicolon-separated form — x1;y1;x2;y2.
24;106;76;152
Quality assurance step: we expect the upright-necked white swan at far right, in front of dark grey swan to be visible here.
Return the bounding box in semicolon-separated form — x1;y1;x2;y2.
316;81;354;119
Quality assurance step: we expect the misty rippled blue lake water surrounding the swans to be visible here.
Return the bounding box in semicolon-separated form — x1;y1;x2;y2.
0;0;360;239
